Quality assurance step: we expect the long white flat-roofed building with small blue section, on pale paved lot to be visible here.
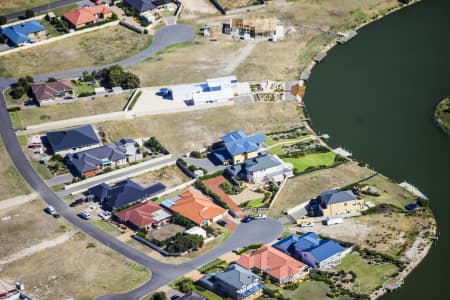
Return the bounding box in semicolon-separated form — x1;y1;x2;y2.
169;76;251;105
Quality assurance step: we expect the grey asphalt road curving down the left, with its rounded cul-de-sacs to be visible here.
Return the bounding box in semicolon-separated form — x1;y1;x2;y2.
0;25;283;300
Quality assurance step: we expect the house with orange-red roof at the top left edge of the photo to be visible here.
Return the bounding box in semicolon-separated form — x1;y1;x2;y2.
63;4;112;29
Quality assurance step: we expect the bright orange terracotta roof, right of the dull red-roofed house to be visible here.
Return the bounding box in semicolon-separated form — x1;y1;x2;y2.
170;191;226;225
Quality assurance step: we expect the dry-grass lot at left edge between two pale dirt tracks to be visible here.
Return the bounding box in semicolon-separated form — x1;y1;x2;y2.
0;200;70;258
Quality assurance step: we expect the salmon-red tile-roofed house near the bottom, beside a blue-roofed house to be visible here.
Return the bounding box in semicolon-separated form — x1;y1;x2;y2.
236;246;308;285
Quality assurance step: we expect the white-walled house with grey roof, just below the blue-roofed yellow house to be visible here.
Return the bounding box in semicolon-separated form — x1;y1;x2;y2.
226;154;294;184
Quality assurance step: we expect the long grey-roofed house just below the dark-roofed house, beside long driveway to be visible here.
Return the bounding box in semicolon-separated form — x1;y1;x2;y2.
66;139;141;177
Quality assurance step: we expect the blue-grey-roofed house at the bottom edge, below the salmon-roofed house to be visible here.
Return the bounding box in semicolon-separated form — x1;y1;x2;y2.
198;264;264;300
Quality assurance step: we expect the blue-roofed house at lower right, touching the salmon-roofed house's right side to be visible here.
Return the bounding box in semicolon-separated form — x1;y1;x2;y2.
272;232;345;269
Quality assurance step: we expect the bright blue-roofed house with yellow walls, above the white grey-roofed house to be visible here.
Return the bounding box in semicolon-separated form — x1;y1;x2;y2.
212;130;266;165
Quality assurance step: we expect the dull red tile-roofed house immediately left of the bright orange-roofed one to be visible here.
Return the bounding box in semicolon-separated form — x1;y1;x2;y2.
115;201;172;229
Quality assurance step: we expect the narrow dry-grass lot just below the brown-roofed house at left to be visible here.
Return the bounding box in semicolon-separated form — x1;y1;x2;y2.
17;93;130;126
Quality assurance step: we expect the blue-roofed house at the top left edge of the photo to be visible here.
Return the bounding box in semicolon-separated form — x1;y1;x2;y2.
1;20;47;47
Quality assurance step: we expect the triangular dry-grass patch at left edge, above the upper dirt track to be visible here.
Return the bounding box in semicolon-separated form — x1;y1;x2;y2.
0;140;31;200
